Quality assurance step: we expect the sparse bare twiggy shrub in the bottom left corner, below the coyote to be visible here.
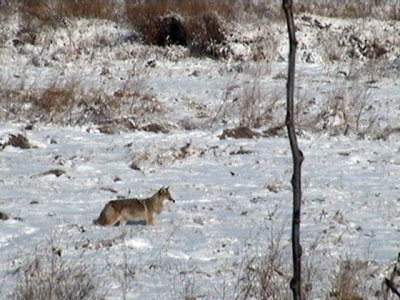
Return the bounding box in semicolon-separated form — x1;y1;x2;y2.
11;247;98;300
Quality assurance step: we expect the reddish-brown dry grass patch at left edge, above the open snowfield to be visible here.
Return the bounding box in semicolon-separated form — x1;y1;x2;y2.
0;69;162;128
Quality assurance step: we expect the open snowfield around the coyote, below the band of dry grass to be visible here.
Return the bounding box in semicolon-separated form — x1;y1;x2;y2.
0;124;400;299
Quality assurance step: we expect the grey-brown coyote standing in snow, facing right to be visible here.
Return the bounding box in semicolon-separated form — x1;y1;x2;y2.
96;187;175;226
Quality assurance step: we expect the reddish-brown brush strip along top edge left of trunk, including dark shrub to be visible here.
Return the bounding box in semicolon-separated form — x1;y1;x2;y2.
0;0;257;58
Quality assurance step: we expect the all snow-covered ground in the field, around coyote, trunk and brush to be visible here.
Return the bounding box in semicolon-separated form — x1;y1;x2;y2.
0;7;400;299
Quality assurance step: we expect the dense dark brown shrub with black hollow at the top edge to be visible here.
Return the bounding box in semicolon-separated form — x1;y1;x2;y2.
126;1;232;58
